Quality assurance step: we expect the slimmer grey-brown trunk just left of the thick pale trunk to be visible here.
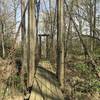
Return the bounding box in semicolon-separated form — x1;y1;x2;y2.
21;0;27;89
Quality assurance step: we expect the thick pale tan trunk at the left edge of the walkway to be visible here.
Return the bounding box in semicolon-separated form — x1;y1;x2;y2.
27;0;36;87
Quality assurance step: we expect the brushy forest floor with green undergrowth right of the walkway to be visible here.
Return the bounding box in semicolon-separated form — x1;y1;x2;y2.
64;55;100;100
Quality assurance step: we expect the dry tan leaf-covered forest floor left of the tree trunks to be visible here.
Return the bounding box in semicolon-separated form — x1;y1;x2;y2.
0;58;22;100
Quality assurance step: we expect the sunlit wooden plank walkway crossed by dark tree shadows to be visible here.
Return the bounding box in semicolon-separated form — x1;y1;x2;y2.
30;62;64;100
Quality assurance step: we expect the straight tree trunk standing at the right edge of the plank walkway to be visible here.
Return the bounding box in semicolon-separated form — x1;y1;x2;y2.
57;0;64;88
